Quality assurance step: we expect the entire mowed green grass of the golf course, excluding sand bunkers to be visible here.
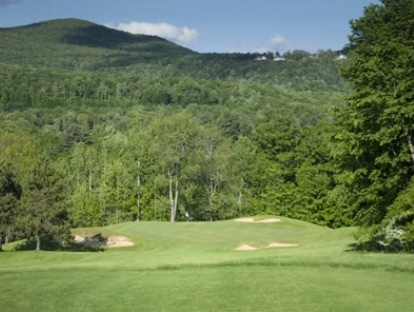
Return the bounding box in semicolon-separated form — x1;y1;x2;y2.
0;218;414;312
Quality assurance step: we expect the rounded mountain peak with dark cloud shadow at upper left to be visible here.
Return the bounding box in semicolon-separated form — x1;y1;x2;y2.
0;19;196;70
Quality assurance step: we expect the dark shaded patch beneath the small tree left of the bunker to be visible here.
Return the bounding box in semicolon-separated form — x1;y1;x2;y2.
14;237;105;252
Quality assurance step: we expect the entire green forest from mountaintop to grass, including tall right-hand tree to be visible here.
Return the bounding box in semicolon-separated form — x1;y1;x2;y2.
0;0;414;251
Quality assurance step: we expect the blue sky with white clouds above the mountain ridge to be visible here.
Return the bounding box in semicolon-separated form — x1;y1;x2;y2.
0;0;380;52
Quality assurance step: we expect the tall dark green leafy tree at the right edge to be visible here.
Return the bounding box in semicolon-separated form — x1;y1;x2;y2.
336;0;414;250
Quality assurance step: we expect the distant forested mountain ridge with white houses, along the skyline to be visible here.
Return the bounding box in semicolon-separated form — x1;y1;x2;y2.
0;19;347;91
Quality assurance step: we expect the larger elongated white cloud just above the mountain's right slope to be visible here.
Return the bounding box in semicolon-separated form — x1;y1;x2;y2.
105;22;200;44
